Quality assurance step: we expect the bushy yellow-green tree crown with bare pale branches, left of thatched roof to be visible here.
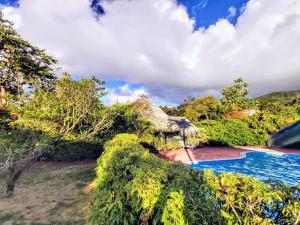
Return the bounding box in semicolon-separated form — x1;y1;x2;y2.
10;74;112;142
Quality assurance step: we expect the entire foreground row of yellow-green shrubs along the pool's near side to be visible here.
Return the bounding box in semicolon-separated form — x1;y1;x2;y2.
87;134;300;225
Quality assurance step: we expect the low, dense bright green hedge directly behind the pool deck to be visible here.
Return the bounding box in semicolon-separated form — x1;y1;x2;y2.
197;119;266;147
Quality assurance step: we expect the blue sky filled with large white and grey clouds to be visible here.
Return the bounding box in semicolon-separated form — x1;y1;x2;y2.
0;0;300;105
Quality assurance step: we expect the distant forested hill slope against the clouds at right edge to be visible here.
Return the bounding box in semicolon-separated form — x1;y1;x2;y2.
256;90;300;105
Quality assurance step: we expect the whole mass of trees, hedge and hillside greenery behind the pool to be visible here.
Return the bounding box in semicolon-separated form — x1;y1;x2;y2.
162;78;300;146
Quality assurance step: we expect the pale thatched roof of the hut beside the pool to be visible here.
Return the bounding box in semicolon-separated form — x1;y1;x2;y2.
133;96;199;136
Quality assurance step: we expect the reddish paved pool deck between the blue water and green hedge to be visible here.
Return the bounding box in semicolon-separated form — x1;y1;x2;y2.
158;146;300;164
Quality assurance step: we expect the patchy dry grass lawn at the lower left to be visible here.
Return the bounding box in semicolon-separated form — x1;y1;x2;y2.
0;164;95;225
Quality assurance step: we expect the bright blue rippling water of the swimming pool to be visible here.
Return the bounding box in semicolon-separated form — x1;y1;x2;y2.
192;152;300;185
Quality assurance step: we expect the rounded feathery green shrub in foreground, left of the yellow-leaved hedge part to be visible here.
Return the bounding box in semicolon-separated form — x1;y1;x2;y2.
88;134;222;225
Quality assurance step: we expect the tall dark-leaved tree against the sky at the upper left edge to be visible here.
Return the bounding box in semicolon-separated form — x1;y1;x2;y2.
0;12;56;109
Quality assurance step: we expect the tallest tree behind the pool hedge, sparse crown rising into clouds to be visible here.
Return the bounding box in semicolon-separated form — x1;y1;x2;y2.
220;78;255;112
